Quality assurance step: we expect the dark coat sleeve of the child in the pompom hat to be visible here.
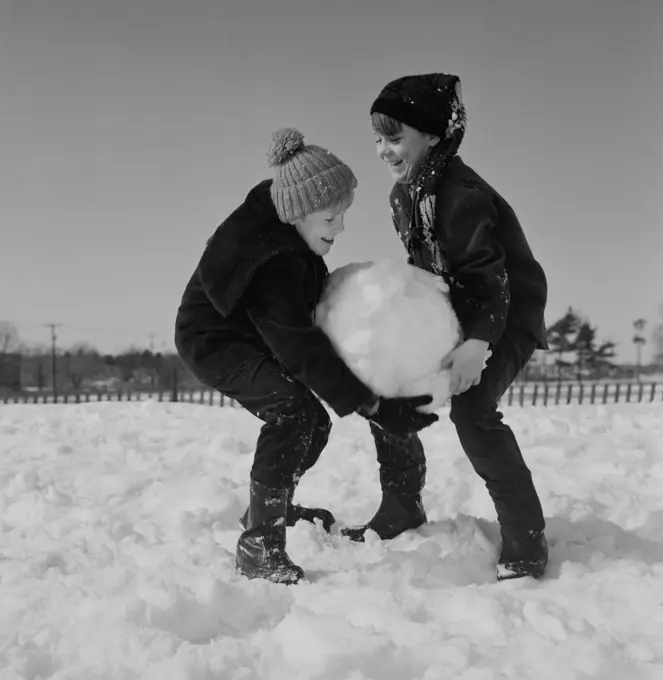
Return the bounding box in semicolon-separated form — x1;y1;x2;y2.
243;255;375;417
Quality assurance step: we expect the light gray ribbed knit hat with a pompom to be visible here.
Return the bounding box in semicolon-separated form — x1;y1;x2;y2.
267;128;357;224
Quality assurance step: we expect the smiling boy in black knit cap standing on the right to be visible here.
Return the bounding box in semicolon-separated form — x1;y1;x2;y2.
358;73;548;579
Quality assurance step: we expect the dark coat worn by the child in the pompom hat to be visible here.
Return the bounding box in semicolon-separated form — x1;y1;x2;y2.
175;180;372;416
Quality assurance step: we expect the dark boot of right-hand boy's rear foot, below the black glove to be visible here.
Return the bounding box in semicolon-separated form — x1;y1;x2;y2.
341;491;426;543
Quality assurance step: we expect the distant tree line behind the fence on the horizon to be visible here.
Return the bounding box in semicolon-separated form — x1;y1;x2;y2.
0;307;663;391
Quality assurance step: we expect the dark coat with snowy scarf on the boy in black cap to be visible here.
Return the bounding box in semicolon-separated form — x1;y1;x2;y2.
390;156;548;349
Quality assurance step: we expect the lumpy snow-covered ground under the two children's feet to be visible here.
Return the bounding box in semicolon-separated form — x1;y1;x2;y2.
0;401;663;680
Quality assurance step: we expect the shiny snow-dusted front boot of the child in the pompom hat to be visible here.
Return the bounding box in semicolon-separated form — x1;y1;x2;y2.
237;479;304;585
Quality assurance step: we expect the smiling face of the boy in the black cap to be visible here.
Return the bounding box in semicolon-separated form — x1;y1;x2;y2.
375;123;440;184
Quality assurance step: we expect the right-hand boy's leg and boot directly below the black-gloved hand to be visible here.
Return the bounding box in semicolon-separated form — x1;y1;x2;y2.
341;423;426;541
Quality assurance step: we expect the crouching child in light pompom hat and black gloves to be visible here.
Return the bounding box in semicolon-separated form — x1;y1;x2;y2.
175;128;437;584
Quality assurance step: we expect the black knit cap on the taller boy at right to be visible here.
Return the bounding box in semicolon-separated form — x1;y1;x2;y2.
371;73;465;139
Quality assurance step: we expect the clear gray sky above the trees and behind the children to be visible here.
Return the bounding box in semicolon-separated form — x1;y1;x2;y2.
0;0;663;360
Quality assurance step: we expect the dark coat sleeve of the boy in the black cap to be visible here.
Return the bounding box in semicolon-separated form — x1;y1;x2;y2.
437;186;511;344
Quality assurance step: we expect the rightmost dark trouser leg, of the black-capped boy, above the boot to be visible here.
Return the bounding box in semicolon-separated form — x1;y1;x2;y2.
450;329;545;537
